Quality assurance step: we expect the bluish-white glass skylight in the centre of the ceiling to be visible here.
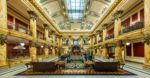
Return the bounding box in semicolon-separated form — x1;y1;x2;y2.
65;0;86;20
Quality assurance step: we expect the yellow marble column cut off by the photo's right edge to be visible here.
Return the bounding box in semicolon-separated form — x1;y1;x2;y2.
144;0;150;66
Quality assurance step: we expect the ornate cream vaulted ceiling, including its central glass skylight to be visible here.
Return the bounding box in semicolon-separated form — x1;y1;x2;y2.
36;0;114;32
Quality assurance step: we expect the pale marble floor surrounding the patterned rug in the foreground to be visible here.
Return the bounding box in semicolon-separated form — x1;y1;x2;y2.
0;56;150;78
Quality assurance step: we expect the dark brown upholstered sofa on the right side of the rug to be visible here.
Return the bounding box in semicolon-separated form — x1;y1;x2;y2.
93;62;119;71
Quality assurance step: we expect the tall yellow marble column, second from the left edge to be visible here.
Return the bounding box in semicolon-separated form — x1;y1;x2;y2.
27;11;37;61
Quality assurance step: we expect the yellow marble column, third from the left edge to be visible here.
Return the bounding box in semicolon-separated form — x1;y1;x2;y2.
44;24;49;56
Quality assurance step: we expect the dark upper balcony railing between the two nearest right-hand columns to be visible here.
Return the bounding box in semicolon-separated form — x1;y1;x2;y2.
120;22;144;35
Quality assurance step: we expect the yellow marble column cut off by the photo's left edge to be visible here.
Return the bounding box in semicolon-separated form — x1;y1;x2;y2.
0;0;7;66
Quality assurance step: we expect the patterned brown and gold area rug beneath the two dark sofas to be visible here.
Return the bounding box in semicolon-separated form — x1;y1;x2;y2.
16;69;136;76
